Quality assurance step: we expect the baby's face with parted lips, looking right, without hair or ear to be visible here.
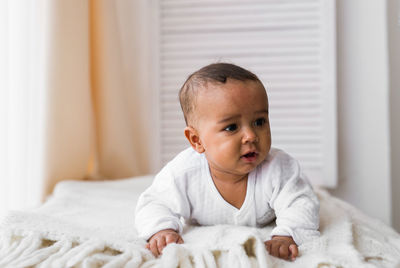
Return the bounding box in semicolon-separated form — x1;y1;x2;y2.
195;79;271;176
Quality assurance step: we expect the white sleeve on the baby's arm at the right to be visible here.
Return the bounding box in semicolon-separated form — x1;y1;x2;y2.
269;151;319;245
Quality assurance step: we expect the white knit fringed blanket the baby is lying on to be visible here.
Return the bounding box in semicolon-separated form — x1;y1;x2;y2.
0;177;400;268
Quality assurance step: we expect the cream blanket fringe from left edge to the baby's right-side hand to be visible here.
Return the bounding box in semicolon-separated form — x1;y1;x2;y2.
0;230;266;268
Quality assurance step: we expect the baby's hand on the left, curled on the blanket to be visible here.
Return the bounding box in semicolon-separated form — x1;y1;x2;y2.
146;229;183;257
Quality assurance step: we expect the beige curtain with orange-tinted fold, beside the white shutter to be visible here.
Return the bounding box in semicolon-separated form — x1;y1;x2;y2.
42;0;151;195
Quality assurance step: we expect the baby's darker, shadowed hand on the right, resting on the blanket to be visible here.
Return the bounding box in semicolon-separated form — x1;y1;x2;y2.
264;236;299;261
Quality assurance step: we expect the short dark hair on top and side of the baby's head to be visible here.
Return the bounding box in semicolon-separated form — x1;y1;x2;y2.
179;62;262;125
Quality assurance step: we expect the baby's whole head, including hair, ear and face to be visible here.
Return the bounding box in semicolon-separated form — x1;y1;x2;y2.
179;63;271;178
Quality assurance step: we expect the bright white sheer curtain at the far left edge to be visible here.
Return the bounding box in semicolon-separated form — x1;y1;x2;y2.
0;1;45;218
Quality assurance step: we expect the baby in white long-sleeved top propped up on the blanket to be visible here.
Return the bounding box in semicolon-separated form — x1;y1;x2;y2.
135;63;319;260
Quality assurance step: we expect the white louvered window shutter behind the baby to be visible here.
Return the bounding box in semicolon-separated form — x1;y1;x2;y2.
155;0;337;187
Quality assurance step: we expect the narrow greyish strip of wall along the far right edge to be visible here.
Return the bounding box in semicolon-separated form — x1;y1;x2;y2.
387;0;400;232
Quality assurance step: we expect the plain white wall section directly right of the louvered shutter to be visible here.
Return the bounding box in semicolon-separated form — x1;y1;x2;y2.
332;0;392;224
